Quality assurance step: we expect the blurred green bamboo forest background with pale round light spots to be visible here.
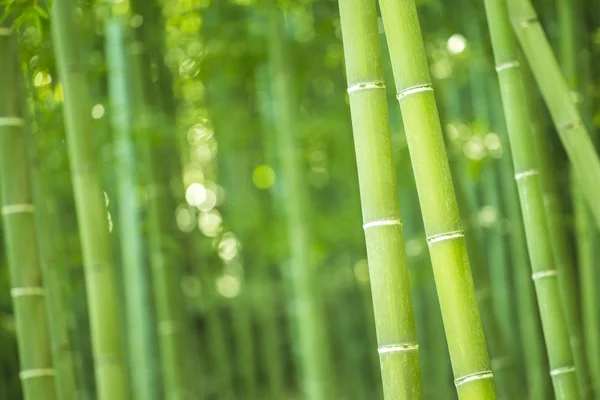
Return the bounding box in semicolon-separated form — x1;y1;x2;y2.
0;0;600;400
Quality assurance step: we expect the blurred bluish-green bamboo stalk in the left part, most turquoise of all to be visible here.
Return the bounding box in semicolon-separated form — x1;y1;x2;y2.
105;17;158;400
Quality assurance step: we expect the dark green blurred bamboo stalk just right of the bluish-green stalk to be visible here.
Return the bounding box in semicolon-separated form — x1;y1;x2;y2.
131;41;187;400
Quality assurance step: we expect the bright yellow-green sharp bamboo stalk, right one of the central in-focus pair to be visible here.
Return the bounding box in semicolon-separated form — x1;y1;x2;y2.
380;0;496;400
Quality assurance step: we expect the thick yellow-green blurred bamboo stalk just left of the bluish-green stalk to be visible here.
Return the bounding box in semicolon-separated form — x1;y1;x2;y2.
52;0;129;400
